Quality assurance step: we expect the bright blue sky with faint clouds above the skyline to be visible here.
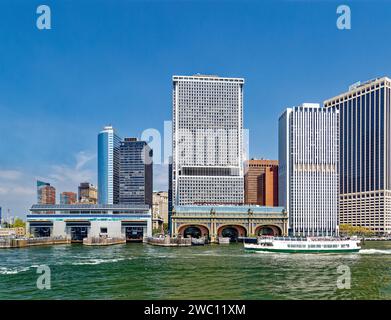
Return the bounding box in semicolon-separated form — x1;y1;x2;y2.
0;0;391;217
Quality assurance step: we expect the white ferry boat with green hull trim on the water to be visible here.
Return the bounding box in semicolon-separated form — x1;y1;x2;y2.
244;237;361;253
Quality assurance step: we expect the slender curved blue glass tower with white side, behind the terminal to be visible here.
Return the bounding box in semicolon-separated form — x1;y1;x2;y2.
98;126;121;204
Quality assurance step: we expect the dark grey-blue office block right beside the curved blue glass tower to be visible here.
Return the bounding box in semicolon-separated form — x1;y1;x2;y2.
119;138;153;206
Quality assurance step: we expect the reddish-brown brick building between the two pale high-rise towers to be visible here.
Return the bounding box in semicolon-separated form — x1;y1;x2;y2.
244;159;278;207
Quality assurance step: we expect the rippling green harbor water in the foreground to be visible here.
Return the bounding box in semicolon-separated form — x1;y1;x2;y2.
0;241;391;299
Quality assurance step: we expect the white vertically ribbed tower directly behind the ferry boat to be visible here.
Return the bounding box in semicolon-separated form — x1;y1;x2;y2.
278;104;339;236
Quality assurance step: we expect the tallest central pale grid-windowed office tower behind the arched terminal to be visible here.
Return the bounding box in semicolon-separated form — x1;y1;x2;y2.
172;75;244;206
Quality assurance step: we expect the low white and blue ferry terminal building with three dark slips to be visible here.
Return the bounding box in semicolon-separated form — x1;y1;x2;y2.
26;204;152;242
